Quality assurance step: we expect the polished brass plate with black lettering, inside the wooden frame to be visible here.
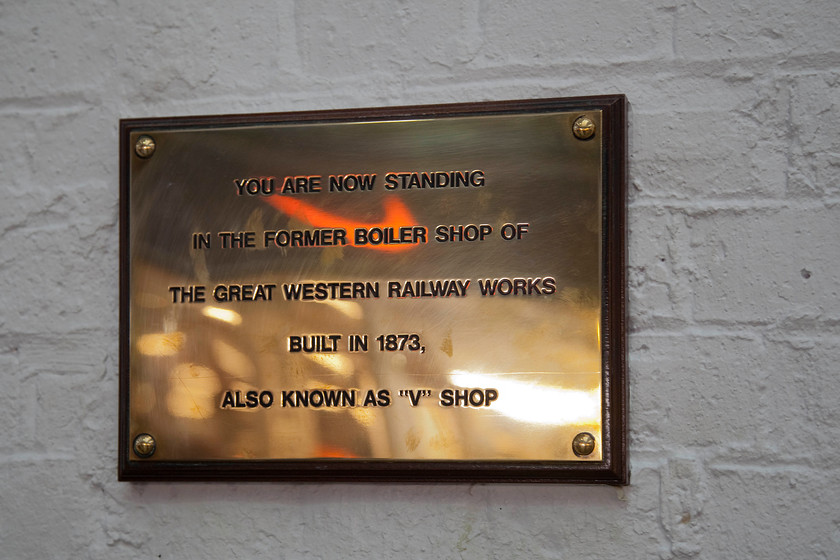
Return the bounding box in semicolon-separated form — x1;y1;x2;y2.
129;111;603;461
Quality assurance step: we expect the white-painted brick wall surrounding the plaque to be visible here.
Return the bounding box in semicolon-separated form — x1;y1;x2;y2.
0;0;840;560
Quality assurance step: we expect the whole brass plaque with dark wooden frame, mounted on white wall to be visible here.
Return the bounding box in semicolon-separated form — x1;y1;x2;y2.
119;95;627;484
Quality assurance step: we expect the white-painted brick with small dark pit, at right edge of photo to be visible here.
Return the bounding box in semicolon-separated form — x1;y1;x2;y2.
686;205;840;323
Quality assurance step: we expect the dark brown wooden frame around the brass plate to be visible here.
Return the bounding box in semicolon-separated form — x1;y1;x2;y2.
118;94;629;485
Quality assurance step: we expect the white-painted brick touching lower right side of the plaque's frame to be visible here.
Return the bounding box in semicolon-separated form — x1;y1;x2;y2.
630;331;840;467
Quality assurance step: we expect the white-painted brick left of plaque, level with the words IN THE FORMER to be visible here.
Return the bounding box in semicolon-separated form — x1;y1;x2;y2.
0;184;119;333
